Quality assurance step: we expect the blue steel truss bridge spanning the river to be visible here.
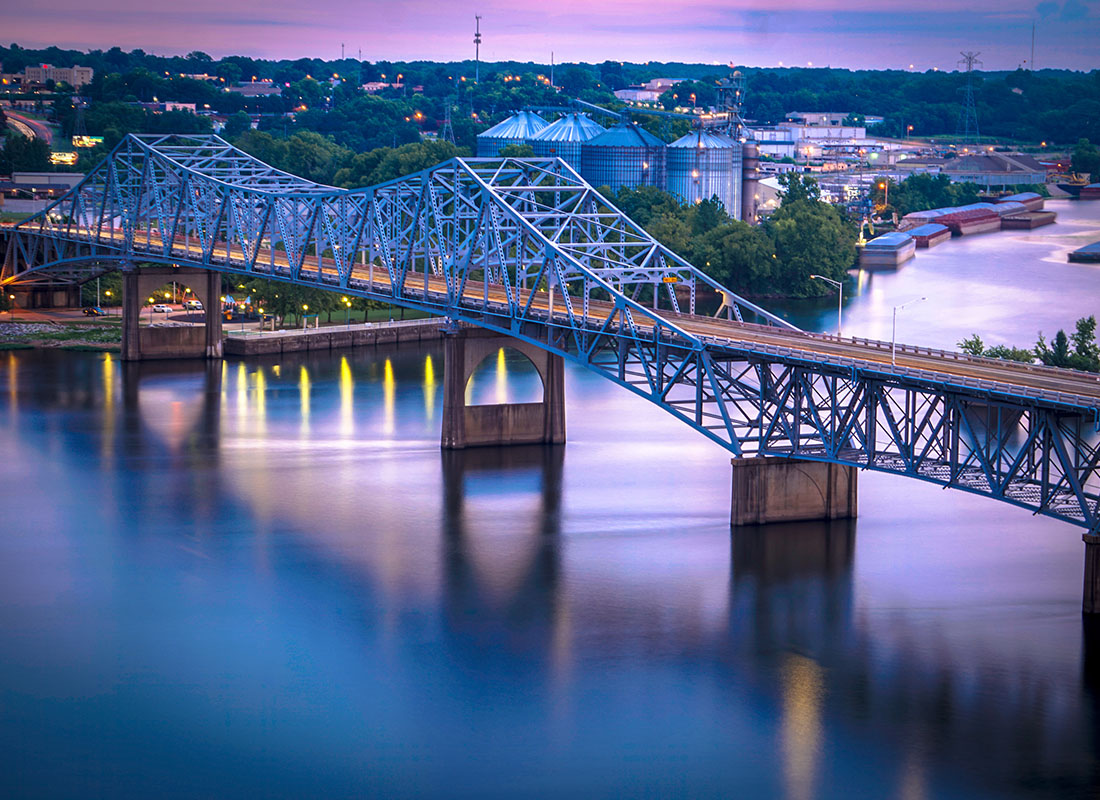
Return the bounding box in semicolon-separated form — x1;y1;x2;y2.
0;135;1100;539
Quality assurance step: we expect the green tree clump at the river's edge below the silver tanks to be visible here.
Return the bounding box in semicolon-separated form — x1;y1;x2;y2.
605;173;856;297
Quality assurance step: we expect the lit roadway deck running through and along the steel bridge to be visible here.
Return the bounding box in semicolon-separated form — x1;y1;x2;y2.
30;230;1100;407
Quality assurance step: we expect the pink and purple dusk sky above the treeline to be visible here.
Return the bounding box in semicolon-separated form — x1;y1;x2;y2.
0;0;1100;69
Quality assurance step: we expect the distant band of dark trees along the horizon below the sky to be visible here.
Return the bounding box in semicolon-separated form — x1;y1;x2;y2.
0;45;1100;151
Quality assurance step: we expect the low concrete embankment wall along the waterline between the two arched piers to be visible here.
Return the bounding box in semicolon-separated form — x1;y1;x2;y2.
224;317;446;355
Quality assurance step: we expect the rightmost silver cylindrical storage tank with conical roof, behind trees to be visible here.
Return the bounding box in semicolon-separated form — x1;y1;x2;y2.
668;130;741;219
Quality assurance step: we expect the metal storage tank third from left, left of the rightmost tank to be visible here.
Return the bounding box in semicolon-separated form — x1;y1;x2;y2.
581;122;668;191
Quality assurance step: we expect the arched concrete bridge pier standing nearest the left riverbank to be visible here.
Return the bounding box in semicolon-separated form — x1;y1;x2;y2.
122;266;222;361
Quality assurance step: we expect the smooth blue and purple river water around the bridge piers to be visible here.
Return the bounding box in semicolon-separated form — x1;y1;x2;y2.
0;196;1100;800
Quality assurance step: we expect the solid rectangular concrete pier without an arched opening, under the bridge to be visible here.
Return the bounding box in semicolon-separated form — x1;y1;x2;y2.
729;457;858;525
